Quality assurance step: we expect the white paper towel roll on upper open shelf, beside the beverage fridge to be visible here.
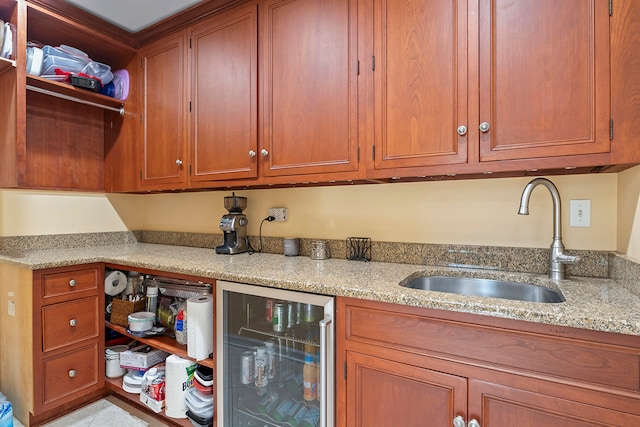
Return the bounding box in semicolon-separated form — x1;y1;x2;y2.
187;296;213;360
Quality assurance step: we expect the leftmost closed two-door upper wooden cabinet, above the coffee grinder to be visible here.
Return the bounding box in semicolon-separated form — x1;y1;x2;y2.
139;3;258;190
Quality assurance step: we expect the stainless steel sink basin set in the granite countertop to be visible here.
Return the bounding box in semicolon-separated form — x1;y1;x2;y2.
400;276;565;303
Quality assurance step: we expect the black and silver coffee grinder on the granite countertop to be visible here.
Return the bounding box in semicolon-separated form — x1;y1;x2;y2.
216;193;249;255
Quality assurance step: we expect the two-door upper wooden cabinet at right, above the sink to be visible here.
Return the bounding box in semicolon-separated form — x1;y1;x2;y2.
365;0;640;178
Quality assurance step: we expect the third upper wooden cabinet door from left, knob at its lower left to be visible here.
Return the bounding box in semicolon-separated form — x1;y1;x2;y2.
260;0;358;176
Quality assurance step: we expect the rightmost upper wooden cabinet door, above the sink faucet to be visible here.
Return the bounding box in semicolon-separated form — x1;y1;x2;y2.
479;0;610;161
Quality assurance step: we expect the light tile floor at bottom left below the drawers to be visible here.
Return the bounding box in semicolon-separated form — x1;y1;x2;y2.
14;396;167;427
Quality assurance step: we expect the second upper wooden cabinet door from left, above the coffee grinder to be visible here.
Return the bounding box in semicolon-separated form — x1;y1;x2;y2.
190;4;258;181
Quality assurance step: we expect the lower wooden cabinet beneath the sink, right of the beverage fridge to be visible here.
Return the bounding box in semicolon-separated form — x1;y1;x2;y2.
336;298;640;427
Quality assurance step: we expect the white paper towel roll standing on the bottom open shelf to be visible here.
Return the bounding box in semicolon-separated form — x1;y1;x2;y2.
164;354;196;418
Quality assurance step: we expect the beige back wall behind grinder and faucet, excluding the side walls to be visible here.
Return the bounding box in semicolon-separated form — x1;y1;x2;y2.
143;174;617;250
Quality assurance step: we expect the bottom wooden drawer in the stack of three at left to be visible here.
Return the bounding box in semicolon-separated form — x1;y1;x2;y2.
42;343;104;405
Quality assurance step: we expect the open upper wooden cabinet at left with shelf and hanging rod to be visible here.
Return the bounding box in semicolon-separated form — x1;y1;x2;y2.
0;0;136;191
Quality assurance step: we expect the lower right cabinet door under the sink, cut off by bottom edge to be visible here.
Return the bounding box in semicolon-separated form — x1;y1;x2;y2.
470;380;640;427
